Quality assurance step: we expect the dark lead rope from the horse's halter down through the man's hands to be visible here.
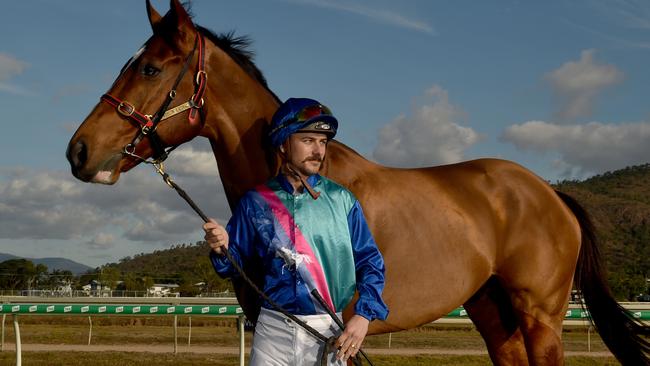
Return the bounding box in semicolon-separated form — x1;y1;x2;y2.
150;164;373;366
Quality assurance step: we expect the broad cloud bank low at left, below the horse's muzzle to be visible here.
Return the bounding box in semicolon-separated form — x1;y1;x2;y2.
0;153;230;250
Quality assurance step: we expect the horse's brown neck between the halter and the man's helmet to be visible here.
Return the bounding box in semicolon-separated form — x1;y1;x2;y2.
201;43;278;209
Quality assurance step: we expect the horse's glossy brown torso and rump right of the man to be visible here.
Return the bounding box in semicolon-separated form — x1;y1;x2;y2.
328;152;580;332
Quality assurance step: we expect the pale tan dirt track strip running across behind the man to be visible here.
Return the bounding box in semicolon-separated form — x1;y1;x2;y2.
4;343;613;357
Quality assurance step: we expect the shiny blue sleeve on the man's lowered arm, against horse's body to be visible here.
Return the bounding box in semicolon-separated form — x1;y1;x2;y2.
348;201;388;320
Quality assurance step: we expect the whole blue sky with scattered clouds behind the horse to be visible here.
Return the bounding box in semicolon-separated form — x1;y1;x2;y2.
0;0;650;267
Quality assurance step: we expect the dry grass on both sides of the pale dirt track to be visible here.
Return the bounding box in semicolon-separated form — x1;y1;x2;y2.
0;316;618;366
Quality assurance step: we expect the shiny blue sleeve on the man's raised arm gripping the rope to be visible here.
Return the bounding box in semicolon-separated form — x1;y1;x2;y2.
210;196;256;278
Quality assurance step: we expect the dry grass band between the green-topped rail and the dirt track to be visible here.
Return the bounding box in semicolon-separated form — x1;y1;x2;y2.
5;316;607;351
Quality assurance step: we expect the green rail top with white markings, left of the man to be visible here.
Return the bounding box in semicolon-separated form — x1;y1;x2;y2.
0;304;243;316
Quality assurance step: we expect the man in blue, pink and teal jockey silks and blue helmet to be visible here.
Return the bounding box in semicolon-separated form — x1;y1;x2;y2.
203;98;388;365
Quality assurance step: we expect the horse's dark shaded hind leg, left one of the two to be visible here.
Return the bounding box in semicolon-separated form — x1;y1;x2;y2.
463;276;528;366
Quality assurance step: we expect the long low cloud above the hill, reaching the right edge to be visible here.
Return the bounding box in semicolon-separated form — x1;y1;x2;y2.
501;121;650;177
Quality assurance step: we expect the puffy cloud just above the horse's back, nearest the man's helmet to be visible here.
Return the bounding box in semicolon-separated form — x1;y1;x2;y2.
373;86;479;167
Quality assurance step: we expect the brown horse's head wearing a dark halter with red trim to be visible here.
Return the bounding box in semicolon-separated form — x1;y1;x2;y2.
66;0;207;184
